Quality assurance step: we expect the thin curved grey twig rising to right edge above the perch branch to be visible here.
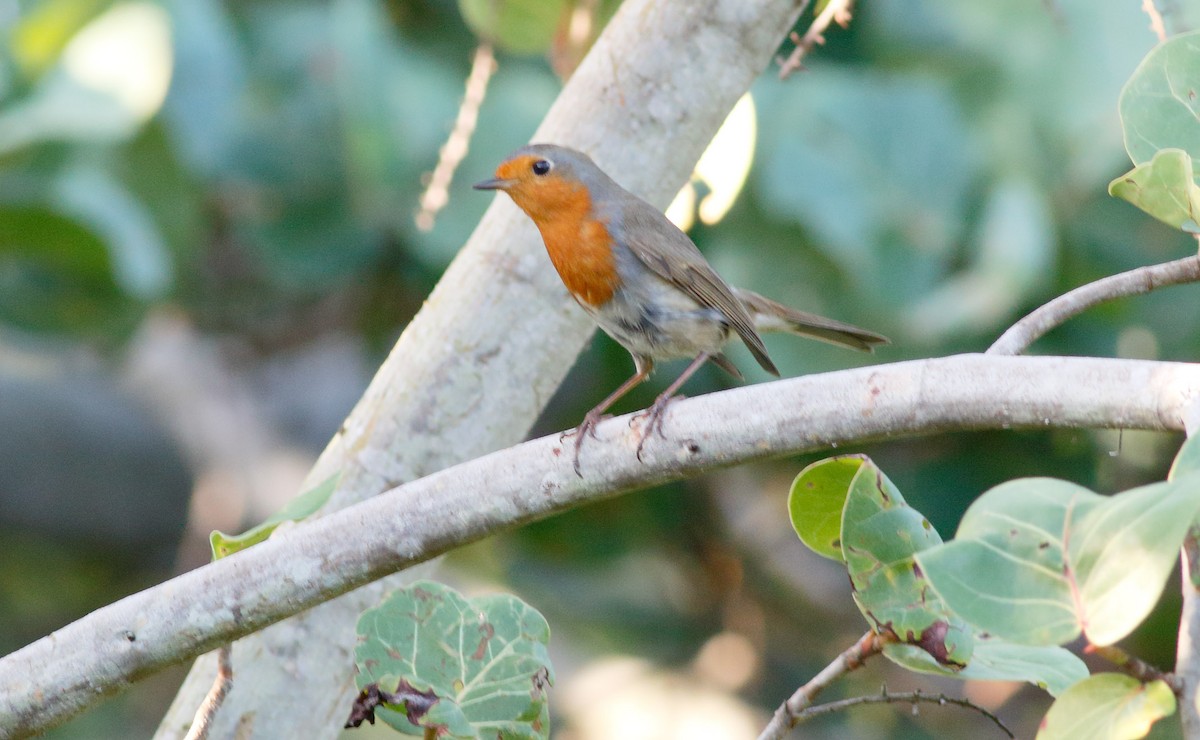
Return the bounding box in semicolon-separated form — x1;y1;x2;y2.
986;255;1200;355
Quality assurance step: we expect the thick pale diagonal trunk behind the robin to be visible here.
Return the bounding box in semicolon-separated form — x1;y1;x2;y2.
157;0;816;740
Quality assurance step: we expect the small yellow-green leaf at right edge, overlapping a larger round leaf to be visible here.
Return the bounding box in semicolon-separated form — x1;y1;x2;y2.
1109;149;1200;234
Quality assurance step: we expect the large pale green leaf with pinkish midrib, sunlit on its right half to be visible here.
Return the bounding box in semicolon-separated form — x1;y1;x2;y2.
917;476;1200;645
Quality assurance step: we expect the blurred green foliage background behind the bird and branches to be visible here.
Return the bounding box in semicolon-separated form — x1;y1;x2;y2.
0;0;1200;740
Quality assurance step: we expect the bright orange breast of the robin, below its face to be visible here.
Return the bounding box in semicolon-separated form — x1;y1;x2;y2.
535;189;618;307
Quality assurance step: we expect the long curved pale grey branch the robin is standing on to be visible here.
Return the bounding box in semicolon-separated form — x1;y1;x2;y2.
0;355;1200;736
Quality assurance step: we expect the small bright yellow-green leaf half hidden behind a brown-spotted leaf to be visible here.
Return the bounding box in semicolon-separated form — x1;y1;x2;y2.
787;455;866;562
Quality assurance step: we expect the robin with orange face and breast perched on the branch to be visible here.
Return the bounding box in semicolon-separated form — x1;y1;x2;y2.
474;144;888;477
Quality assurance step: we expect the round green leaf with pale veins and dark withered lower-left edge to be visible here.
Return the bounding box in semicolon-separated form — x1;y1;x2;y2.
352;580;553;740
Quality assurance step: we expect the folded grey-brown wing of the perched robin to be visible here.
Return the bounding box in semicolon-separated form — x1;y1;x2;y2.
620;201;779;375
